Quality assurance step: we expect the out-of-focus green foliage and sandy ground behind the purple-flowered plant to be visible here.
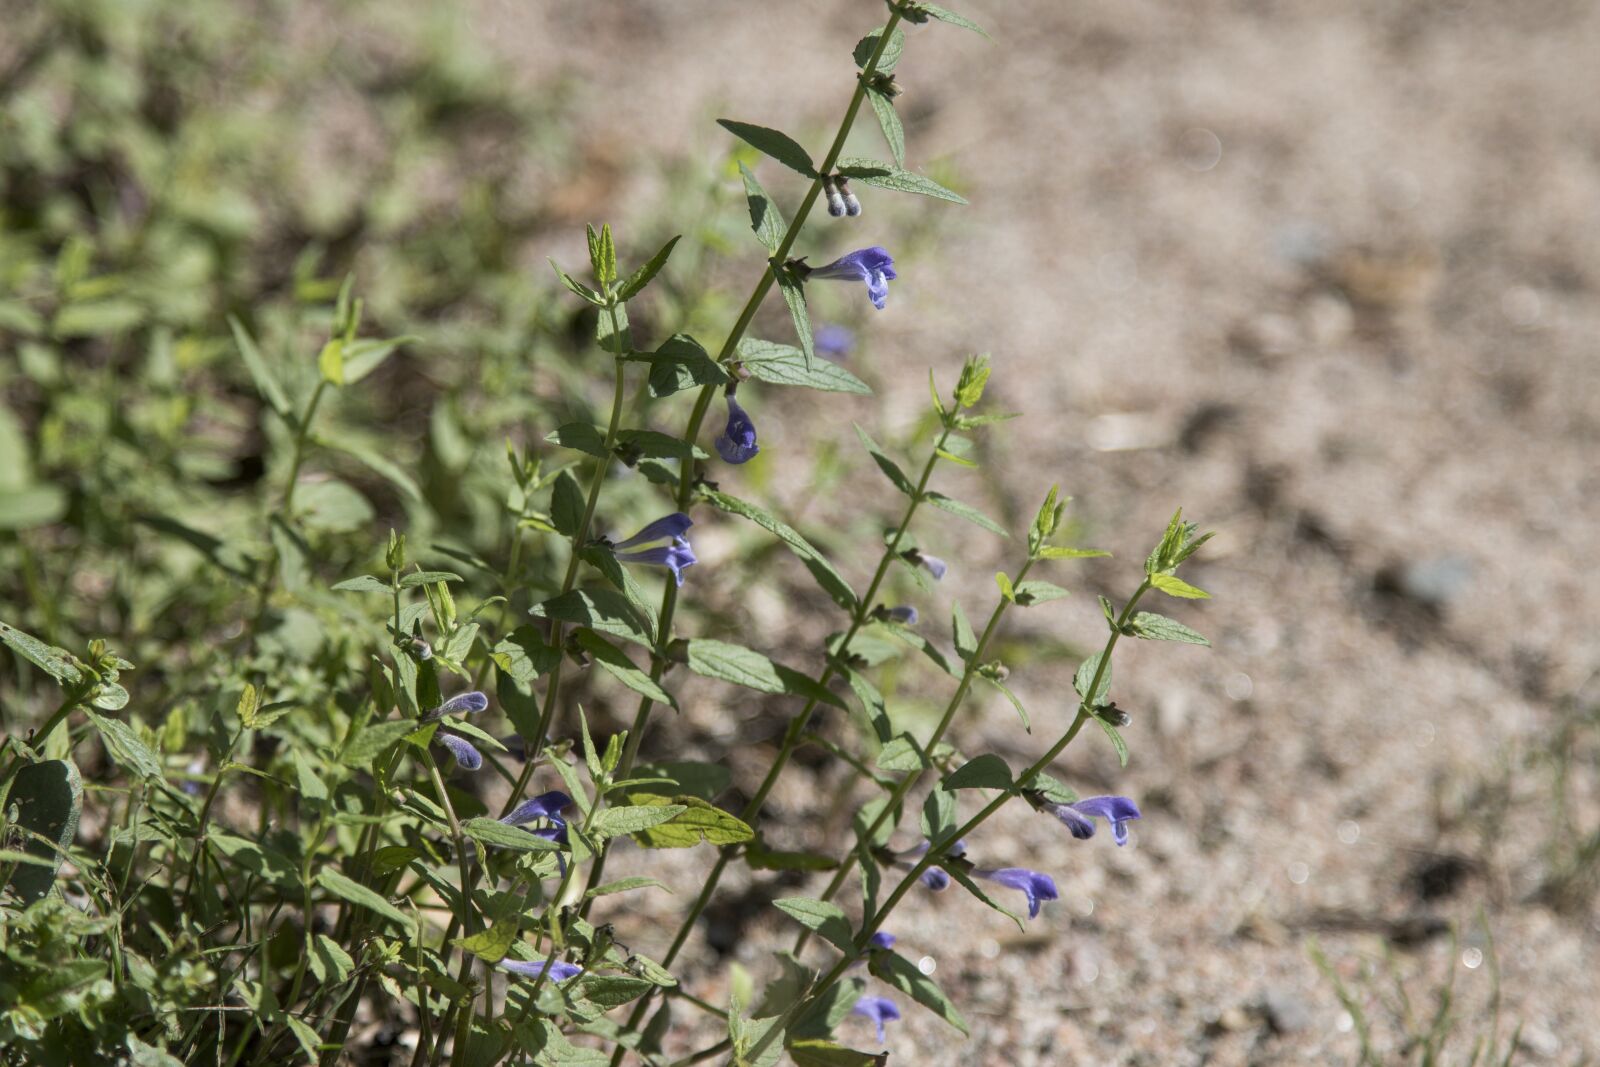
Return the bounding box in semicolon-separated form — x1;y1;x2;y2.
0;0;1600;1064
